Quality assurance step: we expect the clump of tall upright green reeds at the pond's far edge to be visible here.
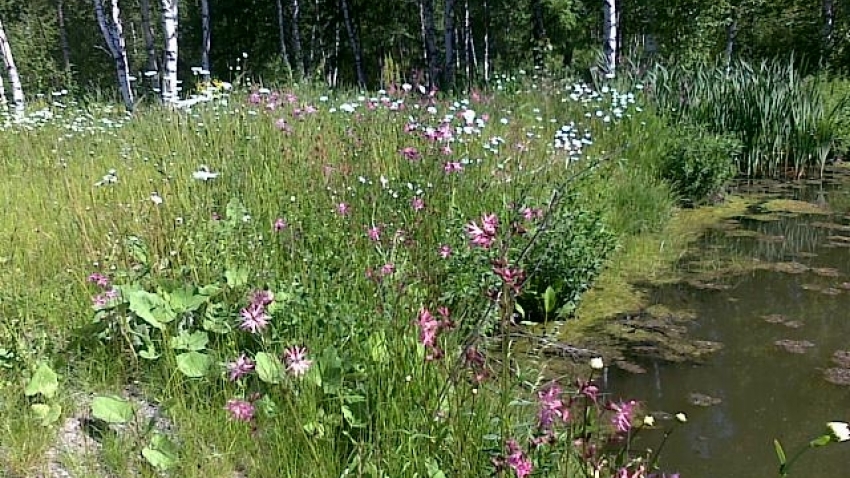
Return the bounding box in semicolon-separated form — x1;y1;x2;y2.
648;60;847;178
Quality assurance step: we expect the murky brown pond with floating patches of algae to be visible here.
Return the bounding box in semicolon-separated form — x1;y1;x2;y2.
606;180;850;478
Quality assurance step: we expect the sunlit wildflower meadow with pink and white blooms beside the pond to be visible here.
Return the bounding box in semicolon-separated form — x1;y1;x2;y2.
0;74;847;478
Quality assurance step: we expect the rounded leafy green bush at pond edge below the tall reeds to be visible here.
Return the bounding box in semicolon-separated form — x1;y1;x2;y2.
659;125;741;204
